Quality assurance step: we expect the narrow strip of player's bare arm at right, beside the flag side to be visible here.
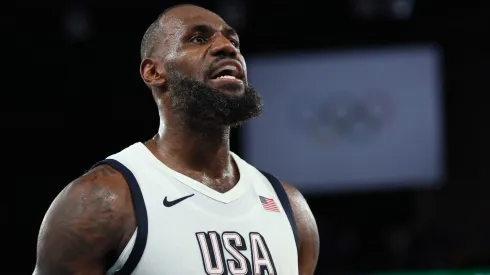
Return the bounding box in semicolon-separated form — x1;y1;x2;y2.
283;184;320;275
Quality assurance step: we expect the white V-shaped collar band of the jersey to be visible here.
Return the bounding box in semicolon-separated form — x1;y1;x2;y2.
135;142;249;203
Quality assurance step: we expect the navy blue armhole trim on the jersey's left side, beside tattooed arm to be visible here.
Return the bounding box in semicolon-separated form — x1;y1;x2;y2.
94;159;148;275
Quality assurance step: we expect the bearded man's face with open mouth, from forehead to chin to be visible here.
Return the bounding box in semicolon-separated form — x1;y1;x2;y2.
160;6;262;126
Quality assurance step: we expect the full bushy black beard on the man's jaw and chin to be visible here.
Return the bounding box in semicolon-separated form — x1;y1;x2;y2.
167;71;262;131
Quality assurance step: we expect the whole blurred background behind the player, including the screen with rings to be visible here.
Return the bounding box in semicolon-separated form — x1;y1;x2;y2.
7;0;490;274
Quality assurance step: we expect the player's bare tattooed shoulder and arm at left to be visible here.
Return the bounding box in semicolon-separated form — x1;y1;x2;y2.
33;165;136;275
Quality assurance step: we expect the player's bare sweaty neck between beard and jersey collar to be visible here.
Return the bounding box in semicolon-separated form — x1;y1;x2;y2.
148;116;233;179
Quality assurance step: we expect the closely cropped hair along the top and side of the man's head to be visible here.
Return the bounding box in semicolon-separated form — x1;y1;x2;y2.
140;4;219;59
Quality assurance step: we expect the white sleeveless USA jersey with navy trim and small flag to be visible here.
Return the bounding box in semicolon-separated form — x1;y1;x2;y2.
99;143;298;275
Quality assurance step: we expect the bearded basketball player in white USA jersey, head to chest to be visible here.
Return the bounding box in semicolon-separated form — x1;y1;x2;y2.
34;5;319;275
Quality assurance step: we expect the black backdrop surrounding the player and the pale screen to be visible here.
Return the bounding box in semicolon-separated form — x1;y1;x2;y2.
7;0;490;274
